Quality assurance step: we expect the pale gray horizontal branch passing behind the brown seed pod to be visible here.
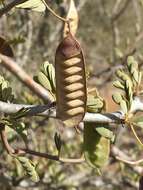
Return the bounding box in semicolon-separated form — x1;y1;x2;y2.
0;97;143;123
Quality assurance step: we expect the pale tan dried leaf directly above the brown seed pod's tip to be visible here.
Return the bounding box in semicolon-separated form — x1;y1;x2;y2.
63;0;79;37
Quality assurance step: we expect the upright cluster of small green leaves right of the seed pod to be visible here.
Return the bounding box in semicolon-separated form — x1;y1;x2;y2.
112;56;142;114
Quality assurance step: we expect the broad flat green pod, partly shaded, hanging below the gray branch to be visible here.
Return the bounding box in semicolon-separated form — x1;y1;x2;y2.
83;123;110;168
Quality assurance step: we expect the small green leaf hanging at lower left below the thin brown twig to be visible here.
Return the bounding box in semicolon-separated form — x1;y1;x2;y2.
15;156;39;182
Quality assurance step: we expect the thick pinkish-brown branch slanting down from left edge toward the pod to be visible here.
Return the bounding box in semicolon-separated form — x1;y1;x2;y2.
0;54;54;102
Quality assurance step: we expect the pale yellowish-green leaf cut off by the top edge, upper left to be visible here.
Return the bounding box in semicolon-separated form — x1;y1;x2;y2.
16;0;46;12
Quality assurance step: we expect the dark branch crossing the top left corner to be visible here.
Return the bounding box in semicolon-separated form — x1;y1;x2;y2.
0;0;27;17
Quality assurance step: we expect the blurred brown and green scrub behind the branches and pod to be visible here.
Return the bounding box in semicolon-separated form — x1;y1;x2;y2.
0;0;143;190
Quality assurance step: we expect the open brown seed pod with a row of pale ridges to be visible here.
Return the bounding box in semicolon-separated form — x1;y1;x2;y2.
55;33;87;127
